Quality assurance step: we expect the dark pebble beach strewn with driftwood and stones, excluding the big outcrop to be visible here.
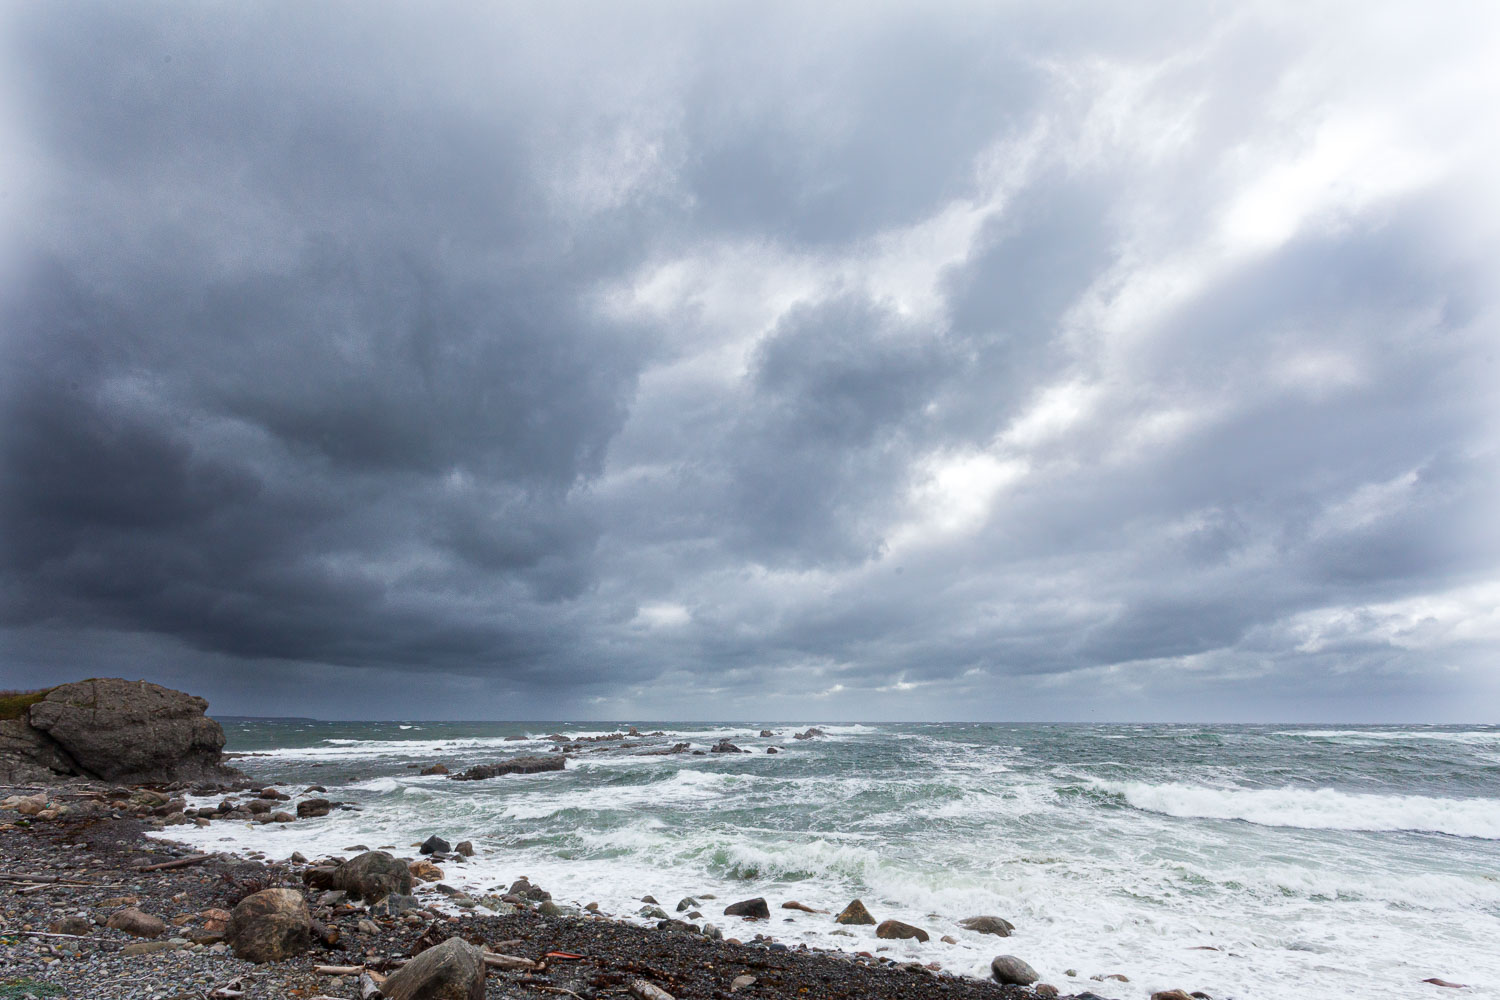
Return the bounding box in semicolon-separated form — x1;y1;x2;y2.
0;780;1134;1000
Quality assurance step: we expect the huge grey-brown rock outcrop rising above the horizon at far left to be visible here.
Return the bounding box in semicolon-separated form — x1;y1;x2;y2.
16;678;245;784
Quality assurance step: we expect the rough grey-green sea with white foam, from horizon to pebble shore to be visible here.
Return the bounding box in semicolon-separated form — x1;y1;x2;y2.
162;720;1500;1000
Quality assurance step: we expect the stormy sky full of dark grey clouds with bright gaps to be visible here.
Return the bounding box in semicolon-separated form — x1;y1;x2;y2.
0;0;1500;721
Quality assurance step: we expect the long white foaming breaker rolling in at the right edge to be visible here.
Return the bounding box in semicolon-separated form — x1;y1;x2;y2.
1098;781;1500;840
